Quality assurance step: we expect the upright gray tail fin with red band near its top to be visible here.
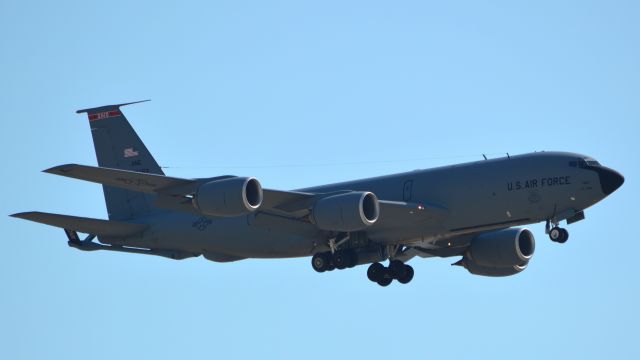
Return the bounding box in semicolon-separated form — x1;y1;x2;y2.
76;100;164;220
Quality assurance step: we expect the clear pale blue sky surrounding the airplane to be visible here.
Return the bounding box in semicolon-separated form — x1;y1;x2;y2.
0;0;640;359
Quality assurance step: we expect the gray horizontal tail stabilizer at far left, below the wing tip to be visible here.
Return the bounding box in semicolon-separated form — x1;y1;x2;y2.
11;211;148;237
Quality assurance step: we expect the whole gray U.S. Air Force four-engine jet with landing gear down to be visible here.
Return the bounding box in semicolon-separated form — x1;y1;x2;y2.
12;103;624;286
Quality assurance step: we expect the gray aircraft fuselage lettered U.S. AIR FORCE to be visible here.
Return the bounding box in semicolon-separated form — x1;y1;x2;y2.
110;152;619;261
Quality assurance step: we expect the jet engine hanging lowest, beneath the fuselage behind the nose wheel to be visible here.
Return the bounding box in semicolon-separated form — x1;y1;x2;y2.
457;228;536;276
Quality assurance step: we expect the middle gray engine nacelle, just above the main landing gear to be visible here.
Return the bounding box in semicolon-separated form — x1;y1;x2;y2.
311;191;380;231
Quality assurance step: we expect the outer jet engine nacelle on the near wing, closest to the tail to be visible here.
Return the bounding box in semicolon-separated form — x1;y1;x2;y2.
192;177;263;217
